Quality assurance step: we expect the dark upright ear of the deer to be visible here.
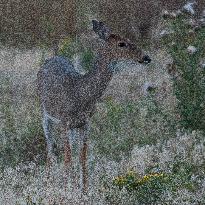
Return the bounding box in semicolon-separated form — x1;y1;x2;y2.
92;20;111;41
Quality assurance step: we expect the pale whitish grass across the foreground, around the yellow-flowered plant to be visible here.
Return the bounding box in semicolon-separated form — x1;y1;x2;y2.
0;132;205;205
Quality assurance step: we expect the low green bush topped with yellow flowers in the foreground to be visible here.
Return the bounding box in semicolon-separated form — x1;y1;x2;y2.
107;158;203;205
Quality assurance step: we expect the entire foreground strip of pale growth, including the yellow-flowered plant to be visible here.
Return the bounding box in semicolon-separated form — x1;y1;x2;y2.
0;132;205;205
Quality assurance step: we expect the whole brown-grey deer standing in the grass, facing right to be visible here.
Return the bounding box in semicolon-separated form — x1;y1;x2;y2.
38;20;151;191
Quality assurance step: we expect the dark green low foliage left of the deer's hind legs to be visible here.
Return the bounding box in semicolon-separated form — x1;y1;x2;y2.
0;115;46;168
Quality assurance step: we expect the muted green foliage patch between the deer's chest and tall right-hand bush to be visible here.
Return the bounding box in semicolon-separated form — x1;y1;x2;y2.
91;95;177;160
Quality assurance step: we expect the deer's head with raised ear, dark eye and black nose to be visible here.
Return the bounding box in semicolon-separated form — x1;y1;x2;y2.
92;20;151;64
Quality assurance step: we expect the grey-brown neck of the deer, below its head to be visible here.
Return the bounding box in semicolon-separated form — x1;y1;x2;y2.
81;53;116;101
